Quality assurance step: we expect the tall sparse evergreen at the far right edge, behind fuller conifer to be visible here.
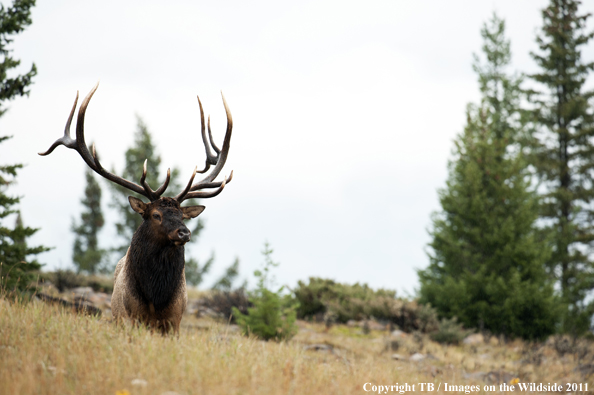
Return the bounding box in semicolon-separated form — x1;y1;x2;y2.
531;0;594;334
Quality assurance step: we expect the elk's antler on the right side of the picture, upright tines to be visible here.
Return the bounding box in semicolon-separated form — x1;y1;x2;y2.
175;92;233;203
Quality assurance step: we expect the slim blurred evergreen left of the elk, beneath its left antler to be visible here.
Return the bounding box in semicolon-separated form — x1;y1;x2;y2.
72;169;106;274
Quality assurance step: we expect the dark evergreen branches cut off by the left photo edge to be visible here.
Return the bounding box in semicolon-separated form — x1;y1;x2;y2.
0;0;48;291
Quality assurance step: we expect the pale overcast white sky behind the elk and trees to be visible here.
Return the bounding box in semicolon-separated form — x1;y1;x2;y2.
0;0;594;295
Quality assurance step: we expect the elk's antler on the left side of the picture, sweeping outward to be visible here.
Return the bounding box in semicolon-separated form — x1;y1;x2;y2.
39;82;170;201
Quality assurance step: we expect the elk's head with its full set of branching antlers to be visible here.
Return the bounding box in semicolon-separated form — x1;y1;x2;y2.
39;83;233;227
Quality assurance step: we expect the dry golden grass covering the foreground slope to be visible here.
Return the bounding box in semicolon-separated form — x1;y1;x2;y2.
0;299;594;395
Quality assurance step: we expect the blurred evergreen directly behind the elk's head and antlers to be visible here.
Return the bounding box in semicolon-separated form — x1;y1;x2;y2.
109;117;212;285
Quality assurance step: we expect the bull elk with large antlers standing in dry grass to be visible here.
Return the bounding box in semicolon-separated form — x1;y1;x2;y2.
39;83;233;334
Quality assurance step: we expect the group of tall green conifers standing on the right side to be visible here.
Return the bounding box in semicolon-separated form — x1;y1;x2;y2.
418;0;594;339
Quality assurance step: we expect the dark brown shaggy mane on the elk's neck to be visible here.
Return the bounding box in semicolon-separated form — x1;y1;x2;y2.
126;221;185;311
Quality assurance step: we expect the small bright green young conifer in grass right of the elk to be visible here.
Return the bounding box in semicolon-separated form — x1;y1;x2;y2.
232;243;298;341
